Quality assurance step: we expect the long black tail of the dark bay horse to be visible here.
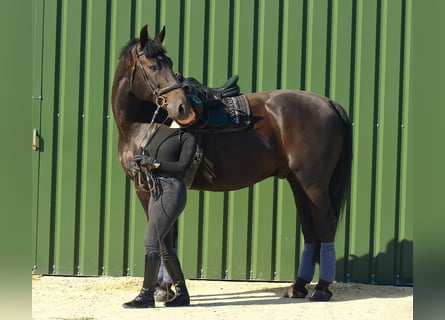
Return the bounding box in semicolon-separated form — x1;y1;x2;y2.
329;100;352;221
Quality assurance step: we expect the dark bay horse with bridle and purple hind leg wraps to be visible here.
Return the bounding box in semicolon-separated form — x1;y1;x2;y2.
112;26;352;301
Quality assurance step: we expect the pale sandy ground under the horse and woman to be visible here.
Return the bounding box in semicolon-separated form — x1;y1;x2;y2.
32;276;413;320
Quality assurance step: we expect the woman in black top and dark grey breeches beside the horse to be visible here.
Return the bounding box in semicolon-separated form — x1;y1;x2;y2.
123;125;196;308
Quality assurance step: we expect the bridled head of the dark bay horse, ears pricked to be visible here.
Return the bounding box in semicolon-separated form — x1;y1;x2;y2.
125;26;195;125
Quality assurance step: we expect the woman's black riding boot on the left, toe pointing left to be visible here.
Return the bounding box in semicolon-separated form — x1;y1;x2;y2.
122;252;161;308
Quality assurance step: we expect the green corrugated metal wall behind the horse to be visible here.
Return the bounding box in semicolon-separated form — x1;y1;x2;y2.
32;0;413;284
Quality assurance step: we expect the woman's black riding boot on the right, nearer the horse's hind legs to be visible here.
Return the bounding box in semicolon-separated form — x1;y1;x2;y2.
164;254;190;307
